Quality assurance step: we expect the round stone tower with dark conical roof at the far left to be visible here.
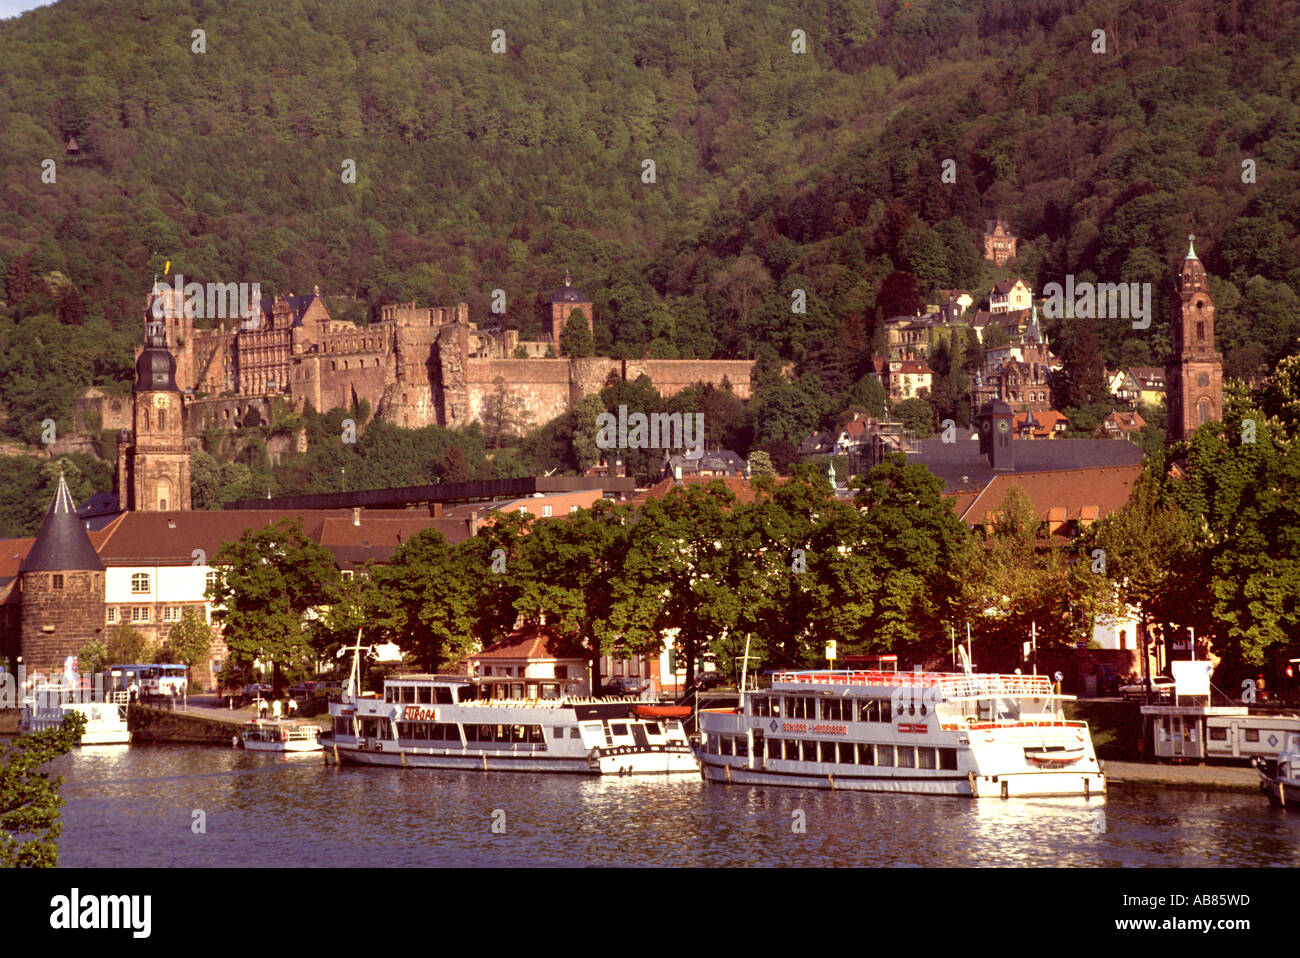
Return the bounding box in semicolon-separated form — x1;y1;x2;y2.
18;473;104;675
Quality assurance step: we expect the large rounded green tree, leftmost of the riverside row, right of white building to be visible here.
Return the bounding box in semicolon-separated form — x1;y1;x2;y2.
207;520;341;682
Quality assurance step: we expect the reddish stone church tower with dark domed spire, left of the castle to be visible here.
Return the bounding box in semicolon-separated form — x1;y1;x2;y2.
117;318;190;512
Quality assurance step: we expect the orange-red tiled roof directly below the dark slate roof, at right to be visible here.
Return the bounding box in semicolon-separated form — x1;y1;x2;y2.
962;464;1141;525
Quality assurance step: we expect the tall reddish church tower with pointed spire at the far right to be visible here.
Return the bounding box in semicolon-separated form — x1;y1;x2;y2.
1165;235;1223;442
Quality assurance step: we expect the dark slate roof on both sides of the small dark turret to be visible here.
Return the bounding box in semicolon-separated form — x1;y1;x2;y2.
907;439;1143;493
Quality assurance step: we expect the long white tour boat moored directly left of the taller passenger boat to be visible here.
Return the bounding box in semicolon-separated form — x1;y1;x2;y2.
324;675;699;775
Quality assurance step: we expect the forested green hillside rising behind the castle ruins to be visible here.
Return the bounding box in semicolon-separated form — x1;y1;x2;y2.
0;0;1300;522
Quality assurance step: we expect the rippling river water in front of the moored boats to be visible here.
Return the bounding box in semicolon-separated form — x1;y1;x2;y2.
40;745;1300;867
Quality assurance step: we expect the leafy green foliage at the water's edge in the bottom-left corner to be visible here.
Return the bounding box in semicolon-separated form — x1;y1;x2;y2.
0;712;86;868
